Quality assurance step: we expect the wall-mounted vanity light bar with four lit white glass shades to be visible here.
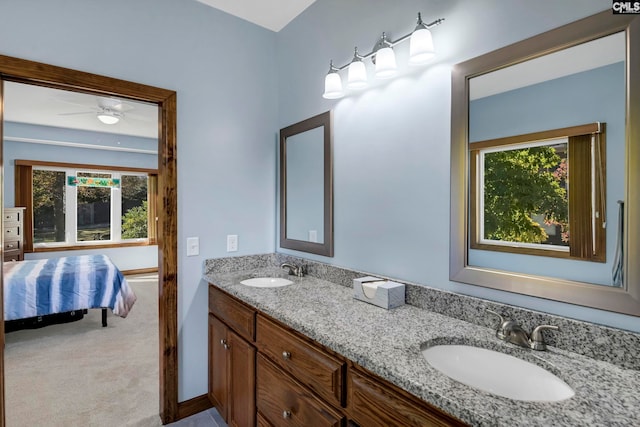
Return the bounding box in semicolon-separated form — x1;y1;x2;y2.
322;13;444;99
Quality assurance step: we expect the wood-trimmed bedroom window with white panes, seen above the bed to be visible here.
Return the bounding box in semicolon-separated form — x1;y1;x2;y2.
15;160;157;251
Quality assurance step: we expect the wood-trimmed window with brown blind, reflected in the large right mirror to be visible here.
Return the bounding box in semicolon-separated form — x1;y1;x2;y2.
469;124;606;262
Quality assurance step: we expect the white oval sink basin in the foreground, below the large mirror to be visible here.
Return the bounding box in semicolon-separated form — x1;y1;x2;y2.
422;345;575;402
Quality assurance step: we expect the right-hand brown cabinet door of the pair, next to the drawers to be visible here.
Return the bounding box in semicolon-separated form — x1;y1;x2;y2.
227;330;256;427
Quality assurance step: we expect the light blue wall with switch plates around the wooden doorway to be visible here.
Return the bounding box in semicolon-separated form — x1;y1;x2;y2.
0;0;279;400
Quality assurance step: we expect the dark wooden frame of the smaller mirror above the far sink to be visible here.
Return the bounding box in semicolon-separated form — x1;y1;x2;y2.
280;111;333;257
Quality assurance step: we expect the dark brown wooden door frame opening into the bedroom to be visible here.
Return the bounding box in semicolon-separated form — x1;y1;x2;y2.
0;55;180;426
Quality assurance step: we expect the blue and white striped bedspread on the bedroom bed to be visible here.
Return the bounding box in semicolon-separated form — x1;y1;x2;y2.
3;255;136;320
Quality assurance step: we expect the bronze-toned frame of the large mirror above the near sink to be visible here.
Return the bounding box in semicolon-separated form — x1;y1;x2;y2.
449;10;640;316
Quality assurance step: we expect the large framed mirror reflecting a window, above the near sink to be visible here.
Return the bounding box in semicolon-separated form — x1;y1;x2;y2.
450;11;640;316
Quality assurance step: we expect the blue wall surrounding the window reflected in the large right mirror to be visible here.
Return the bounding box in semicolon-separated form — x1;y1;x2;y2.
469;62;626;285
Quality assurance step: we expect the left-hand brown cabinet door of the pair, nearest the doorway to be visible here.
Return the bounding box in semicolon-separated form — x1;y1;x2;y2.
209;314;229;421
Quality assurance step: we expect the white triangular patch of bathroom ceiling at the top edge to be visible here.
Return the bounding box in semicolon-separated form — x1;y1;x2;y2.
198;0;315;32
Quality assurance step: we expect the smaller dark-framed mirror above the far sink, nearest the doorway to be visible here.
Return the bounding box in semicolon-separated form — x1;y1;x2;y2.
280;111;333;257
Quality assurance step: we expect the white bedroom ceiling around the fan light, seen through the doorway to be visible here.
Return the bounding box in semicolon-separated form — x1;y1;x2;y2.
4;82;158;139
